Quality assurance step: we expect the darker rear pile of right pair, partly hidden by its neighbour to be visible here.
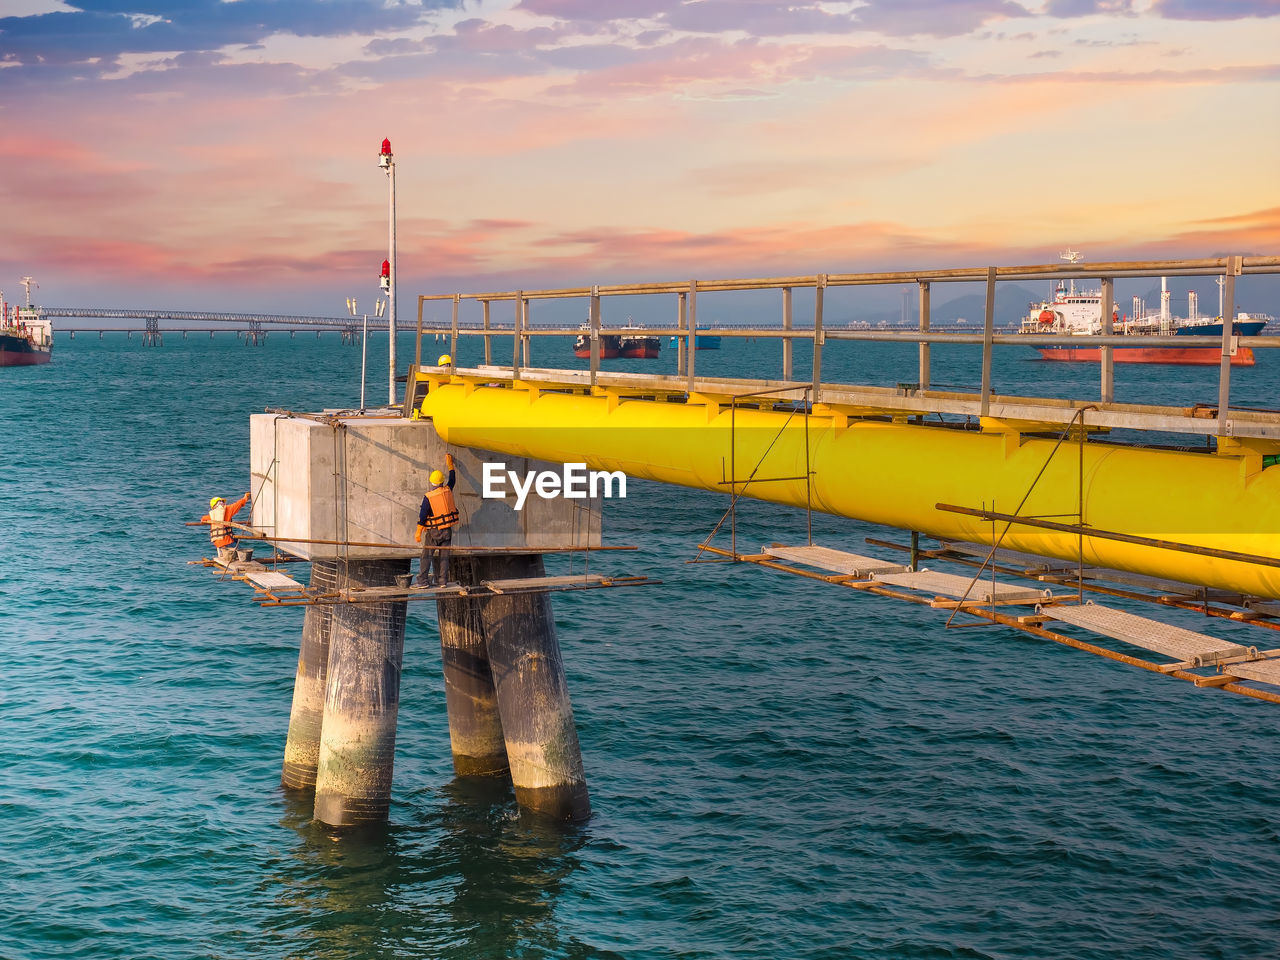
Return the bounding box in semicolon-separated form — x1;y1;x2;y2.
435;557;507;777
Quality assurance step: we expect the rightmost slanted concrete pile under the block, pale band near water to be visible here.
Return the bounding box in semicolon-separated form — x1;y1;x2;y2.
477;554;591;820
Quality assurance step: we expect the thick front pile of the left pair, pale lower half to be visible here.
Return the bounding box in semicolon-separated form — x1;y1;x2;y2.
315;559;410;827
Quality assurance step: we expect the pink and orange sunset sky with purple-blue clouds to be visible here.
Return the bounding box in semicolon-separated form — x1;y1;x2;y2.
0;0;1280;315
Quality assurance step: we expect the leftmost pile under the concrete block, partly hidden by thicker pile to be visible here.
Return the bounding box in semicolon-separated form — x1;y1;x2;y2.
280;561;338;791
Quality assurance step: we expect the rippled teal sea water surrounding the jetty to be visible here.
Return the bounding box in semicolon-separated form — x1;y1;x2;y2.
0;333;1280;960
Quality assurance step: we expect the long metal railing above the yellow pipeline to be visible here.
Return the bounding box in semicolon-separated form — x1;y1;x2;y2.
415;256;1280;435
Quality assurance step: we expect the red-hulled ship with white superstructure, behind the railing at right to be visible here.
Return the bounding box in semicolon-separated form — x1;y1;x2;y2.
1019;251;1271;366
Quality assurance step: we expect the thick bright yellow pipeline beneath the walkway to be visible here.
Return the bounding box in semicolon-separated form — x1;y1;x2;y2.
421;379;1280;598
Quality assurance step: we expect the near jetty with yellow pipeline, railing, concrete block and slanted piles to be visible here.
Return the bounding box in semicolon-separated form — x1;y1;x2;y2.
201;256;1280;827
